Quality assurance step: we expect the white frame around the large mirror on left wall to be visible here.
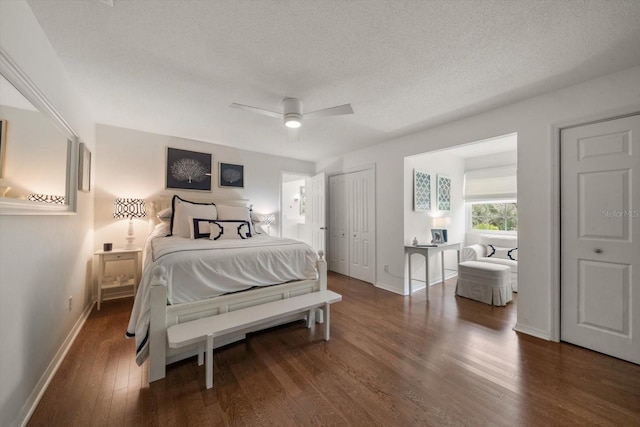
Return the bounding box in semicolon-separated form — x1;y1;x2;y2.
0;47;79;215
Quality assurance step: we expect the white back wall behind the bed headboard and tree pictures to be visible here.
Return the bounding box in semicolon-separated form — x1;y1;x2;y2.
94;124;314;282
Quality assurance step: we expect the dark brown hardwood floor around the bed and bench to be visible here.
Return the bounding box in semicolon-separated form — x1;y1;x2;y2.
29;273;640;426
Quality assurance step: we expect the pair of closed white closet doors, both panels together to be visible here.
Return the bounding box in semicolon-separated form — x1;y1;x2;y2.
328;169;375;283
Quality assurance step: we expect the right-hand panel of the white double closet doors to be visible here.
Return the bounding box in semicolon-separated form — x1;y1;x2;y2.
346;169;375;283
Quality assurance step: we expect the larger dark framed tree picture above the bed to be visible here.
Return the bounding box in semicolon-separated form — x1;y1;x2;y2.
167;147;211;191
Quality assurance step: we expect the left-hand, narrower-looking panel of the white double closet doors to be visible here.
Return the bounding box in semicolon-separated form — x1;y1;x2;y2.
328;175;349;276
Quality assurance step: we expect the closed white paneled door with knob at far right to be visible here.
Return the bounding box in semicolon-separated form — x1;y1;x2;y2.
560;115;640;363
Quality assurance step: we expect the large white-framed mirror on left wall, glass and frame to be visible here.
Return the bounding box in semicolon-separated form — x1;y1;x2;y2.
0;48;78;215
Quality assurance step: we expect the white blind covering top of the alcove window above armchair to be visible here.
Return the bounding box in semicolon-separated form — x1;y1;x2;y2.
464;166;518;202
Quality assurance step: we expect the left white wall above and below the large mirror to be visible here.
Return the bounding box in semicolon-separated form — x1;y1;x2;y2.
0;0;95;426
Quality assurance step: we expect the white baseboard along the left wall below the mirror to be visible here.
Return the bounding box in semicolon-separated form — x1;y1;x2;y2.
12;303;95;427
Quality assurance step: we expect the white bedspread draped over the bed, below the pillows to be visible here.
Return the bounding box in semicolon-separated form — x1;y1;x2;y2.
127;231;318;365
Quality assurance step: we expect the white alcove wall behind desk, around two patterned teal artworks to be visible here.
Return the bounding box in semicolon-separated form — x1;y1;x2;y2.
404;151;465;294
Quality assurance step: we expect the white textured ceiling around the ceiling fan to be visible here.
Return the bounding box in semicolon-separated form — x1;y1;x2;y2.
28;0;640;161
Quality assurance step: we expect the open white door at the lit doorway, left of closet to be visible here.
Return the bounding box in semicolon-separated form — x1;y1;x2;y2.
305;172;327;253
